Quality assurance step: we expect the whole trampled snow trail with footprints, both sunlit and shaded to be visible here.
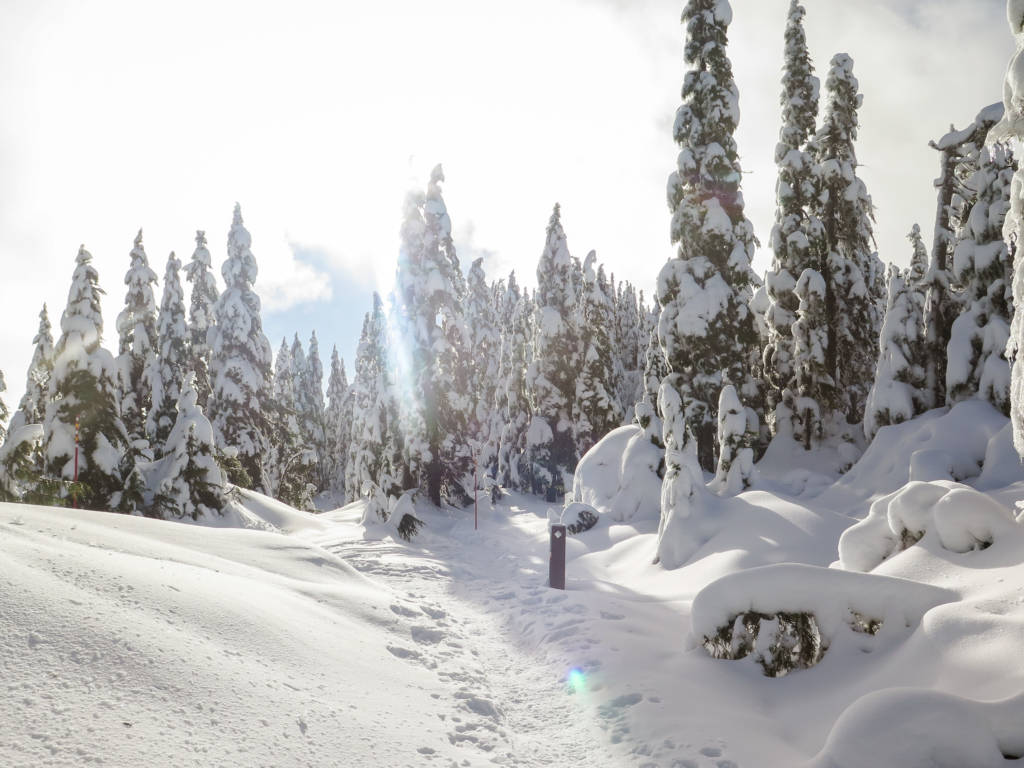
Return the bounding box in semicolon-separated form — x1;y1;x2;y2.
309;506;736;768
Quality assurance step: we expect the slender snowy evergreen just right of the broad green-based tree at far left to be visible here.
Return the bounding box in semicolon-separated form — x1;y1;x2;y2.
117;229;158;450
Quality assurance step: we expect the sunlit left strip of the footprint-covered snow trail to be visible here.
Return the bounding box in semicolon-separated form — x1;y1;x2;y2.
328;541;623;768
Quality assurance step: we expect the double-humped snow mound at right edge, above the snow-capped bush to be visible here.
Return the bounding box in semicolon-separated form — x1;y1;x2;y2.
839;480;1016;571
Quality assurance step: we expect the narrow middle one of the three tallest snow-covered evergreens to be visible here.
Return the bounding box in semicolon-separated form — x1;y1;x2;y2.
763;0;820;429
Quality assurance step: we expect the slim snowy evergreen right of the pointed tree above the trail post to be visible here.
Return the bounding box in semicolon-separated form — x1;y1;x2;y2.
574;251;623;456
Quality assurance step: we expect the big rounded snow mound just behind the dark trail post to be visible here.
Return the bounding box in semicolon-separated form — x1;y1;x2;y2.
572;425;665;522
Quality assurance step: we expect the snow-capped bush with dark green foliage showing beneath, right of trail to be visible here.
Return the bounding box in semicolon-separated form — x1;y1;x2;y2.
691;563;958;677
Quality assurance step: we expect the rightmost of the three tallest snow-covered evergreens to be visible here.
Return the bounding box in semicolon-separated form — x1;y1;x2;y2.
805;53;885;424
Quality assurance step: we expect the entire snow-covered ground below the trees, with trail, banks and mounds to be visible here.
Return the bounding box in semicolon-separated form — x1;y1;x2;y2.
0;403;1024;768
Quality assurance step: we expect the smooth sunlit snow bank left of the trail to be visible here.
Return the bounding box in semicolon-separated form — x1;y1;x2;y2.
0;504;452;767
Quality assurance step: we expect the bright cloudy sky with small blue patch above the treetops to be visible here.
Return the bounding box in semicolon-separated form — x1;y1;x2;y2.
0;0;1013;408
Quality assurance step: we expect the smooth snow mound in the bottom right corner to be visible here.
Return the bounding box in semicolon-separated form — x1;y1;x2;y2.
807;688;1024;768
